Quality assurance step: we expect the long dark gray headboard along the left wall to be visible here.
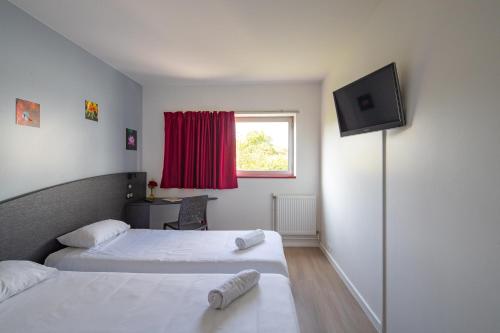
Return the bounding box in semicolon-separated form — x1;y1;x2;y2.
0;172;146;262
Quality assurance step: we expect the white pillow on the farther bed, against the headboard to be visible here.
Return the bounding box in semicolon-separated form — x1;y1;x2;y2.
57;220;130;249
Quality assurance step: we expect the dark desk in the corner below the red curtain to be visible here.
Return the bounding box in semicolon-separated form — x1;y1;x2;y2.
125;197;217;229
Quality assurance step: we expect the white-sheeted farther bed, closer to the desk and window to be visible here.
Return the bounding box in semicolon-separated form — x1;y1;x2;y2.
45;229;288;276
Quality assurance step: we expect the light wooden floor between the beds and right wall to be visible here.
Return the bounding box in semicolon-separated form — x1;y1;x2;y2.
285;247;377;333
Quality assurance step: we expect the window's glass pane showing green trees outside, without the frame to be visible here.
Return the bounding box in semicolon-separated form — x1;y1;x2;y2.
236;121;288;171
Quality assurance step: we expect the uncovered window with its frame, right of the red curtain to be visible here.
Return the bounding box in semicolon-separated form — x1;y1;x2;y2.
236;114;295;178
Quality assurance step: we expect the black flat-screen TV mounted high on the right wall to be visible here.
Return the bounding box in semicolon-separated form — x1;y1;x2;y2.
333;63;406;136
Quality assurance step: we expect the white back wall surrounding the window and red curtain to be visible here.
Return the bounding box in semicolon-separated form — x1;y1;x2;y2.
143;82;321;229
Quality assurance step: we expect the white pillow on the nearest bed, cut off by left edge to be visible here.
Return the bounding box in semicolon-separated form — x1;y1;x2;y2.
0;260;57;302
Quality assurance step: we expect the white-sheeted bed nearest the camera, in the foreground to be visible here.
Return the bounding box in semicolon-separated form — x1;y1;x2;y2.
0;272;299;333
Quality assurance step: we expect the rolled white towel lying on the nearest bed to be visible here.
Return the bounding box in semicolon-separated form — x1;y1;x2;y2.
208;269;260;309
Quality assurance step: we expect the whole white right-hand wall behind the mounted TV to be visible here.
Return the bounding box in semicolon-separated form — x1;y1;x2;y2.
321;0;500;333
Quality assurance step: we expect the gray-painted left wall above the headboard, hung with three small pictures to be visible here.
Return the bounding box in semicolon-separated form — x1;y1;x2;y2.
0;0;142;200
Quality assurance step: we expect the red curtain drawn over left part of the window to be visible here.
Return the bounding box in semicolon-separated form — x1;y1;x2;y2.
161;111;238;189
